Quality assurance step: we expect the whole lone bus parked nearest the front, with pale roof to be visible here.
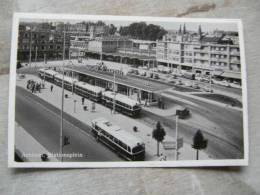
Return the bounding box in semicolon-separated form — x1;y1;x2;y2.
91;118;145;161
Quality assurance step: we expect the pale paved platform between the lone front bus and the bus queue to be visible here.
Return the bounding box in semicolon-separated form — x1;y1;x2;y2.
17;75;208;160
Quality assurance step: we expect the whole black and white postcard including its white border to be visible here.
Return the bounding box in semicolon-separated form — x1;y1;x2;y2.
8;13;248;168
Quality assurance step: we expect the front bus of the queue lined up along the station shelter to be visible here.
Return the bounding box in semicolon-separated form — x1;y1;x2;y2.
102;91;141;117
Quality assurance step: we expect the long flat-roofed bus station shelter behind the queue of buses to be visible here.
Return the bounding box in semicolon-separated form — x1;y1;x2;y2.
65;66;171;106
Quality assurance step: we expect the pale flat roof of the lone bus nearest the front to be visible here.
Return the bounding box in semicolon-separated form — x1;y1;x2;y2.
92;118;144;148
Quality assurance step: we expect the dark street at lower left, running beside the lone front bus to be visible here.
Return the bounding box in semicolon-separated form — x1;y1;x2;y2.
15;87;122;161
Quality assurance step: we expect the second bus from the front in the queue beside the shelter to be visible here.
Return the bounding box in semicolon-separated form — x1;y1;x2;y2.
74;81;105;102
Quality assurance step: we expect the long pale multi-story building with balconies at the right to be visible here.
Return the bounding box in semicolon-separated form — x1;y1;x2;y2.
156;30;241;80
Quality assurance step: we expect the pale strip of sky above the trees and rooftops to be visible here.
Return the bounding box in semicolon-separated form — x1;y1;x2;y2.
21;19;238;32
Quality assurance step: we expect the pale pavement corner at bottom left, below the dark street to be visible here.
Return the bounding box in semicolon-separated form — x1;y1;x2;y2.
15;123;58;162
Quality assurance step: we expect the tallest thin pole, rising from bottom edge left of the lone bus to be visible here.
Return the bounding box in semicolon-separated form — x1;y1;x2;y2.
60;30;66;162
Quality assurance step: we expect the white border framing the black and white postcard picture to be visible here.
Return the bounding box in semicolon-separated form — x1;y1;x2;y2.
8;13;249;168
